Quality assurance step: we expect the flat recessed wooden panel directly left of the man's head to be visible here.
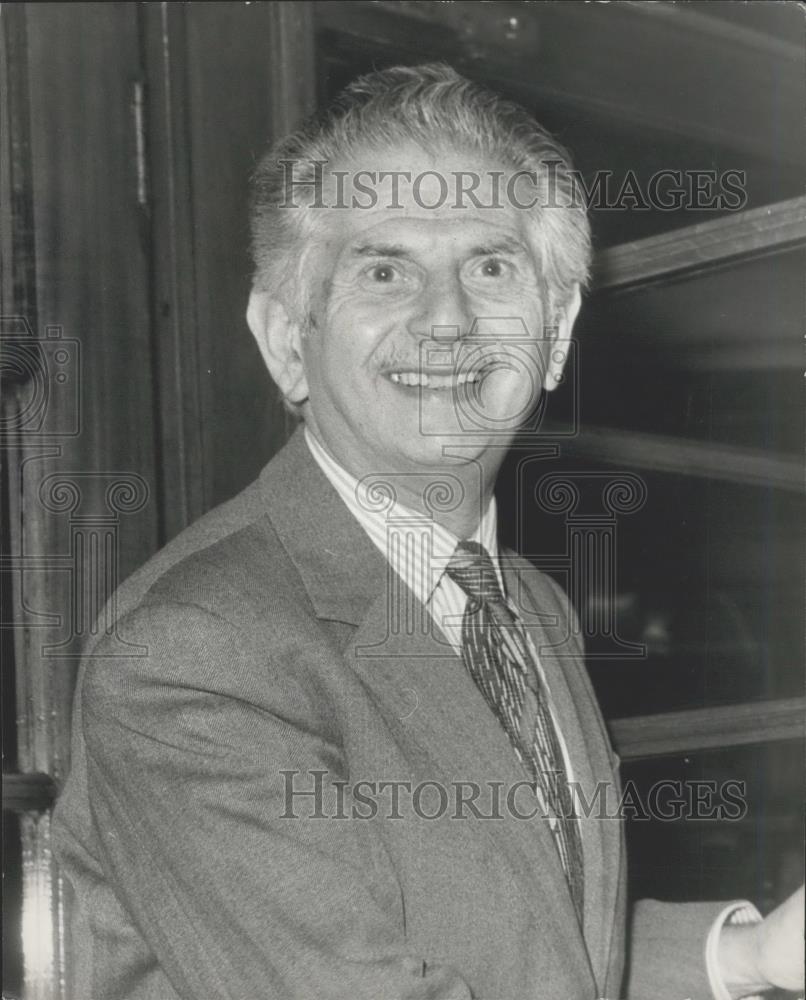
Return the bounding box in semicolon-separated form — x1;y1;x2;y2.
185;3;304;503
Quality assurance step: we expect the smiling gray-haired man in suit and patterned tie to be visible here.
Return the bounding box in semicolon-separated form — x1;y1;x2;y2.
57;66;799;1000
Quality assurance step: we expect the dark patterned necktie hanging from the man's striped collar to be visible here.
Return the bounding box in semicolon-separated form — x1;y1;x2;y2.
446;541;584;922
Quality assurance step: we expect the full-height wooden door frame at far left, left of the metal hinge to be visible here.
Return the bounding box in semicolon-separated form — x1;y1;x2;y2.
2;4;157;1000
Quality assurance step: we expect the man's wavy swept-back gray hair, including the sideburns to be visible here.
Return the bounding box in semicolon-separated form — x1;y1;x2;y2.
251;63;591;323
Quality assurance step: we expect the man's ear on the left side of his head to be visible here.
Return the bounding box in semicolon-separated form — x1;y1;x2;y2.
246;291;308;403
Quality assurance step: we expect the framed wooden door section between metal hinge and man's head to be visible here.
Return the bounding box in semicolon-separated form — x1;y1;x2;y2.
144;3;313;516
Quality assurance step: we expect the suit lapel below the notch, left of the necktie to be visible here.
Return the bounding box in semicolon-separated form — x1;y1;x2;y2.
347;582;592;975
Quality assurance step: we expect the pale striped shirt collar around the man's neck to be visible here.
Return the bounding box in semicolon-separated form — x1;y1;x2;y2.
305;427;501;604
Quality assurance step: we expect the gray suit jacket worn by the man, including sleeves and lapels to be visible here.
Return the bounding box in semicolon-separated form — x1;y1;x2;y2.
55;433;728;1000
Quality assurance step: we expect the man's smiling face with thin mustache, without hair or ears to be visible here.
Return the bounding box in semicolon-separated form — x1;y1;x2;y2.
288;148;568;477
